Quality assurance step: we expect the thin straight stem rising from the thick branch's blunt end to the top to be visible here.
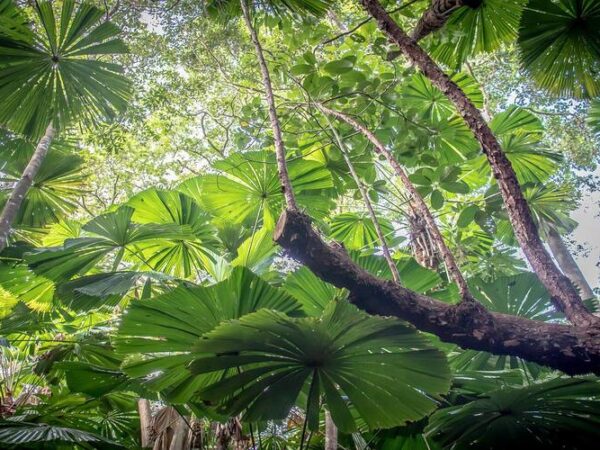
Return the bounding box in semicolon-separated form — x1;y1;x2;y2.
240;0;298;210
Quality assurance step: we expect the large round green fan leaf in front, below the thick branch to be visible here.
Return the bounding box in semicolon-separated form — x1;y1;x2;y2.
191;302;449;432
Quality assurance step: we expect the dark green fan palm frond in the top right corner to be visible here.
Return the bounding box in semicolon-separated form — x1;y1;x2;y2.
519;0;600;97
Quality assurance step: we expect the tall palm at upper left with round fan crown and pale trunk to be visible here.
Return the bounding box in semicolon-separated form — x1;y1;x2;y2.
0;0;129;251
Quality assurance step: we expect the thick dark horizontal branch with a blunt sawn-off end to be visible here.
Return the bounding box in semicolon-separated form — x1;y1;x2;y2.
274;210;600;375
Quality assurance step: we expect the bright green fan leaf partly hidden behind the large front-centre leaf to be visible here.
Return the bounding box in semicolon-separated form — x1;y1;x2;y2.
116;267;300;403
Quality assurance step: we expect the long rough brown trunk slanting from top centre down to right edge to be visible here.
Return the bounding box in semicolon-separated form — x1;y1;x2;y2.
360;0;600;326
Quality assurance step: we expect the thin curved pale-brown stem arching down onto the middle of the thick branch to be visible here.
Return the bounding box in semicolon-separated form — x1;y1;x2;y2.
320;105;473;300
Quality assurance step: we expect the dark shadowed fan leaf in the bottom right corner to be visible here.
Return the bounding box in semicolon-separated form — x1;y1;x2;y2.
427;378;600;449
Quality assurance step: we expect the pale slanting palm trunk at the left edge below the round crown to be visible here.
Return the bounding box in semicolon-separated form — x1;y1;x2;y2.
0;124;56;252
